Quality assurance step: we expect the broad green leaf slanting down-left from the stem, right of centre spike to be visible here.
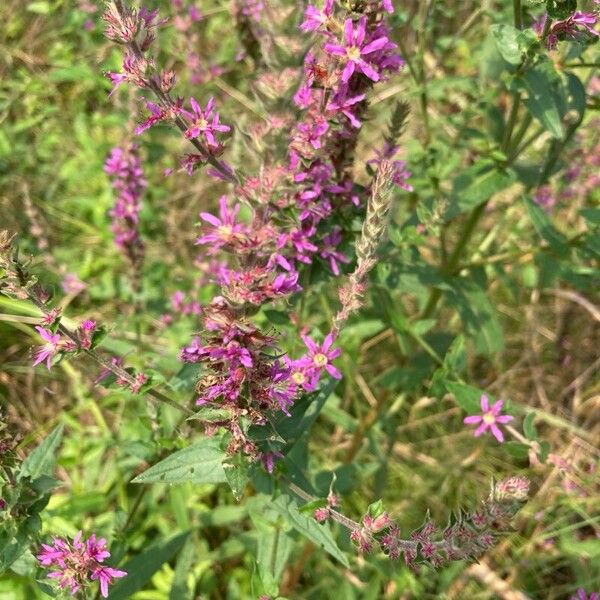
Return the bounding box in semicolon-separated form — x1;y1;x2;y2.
445;159;516;220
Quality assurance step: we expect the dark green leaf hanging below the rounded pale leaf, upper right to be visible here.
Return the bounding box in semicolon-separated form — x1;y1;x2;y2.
520;63;564;139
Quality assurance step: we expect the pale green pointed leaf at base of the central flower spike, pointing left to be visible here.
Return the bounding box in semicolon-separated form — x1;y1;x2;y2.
133;438;227;483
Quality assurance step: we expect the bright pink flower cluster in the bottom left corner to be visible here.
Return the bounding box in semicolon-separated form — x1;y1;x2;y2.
37;531;127;598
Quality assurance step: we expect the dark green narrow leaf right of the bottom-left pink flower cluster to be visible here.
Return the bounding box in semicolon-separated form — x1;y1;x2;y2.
108;531;189;600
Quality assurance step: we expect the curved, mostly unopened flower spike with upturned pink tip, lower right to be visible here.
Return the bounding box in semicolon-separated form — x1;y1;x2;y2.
350;476;529;568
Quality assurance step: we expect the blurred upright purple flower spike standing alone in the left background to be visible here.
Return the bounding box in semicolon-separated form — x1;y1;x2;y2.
104;144;148;267
